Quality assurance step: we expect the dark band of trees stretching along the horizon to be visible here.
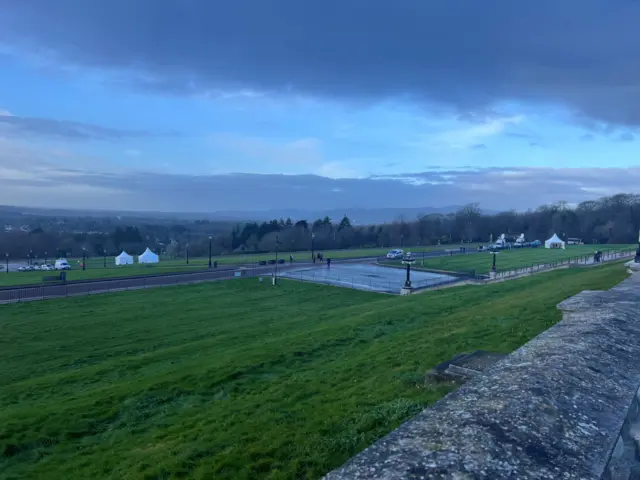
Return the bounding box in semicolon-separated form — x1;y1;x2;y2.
0;194;640;258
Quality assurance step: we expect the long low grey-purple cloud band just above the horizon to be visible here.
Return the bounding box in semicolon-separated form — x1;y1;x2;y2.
0;142;640;212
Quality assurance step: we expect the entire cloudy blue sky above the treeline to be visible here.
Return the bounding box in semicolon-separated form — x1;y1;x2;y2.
0;0;640;212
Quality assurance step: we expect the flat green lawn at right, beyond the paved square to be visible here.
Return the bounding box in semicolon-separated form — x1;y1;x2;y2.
393;245;636;273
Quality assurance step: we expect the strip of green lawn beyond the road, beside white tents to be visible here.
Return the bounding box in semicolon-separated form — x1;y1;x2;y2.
0;246;451;286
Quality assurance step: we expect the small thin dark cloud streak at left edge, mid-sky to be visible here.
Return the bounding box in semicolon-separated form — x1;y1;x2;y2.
0;115;170;140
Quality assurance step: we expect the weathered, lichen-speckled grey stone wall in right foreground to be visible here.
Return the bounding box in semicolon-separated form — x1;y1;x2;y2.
325;275;640;480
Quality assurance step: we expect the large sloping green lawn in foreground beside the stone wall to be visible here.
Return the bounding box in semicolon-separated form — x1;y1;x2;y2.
0;264;626;480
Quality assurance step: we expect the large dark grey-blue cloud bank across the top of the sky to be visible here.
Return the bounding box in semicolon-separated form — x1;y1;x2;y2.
0;0;640;125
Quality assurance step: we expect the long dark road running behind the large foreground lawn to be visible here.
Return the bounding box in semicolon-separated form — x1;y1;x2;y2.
0;251;472;304
